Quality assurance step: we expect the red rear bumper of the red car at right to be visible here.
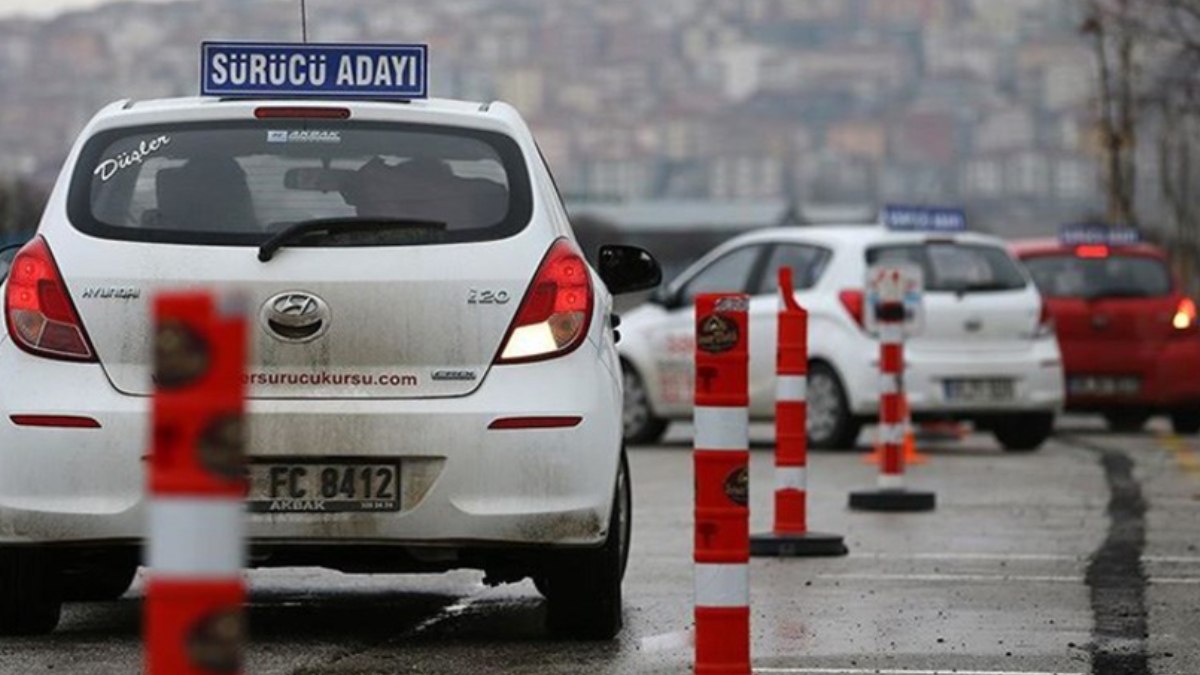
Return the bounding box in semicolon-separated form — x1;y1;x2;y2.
1063;336;1200;412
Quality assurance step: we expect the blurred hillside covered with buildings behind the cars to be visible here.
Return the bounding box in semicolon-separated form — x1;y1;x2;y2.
0;0;1100;241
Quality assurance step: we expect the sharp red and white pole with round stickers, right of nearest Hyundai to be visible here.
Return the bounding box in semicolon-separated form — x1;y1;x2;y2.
694;294;750;675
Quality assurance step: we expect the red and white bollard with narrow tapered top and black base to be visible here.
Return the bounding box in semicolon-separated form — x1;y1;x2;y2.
750;267;847;557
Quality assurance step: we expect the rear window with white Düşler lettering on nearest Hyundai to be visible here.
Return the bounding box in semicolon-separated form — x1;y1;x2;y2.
68;120;533;246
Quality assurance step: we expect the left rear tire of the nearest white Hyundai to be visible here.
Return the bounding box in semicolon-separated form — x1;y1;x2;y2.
0;549;62;635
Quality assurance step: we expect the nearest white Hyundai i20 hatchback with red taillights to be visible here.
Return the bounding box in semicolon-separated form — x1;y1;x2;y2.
0;97;660;638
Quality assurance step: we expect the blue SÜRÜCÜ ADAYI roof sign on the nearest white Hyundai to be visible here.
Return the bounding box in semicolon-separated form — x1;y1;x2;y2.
200;42;430;98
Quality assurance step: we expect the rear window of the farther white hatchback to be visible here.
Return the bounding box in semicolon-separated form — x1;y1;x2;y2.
866;243;1028;293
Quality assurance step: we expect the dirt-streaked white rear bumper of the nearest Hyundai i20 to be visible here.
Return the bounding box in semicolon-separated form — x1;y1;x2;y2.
0;342;620;546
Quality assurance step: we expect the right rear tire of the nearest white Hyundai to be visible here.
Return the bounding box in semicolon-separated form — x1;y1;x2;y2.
538;450;632;640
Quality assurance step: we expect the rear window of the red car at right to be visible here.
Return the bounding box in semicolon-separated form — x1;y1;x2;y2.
1025;255;1171;298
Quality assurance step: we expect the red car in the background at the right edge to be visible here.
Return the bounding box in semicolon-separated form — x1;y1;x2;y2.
1013;233;1200;434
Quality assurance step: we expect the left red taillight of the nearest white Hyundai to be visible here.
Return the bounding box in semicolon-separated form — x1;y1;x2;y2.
5;237;96;362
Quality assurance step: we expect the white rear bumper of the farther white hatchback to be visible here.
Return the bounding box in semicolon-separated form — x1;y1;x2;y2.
852;339;1064;418
